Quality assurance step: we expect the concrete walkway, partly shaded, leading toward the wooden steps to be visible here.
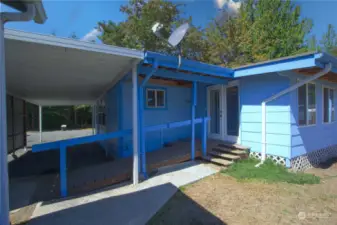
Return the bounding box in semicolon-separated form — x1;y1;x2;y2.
28;162;217;225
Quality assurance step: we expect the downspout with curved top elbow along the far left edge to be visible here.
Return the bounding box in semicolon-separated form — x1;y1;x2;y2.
0;4;36;225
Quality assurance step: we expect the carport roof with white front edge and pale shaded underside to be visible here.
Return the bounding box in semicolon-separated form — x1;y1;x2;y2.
5;29;144;106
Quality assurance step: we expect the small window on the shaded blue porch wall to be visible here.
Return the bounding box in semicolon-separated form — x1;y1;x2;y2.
146;88;166;108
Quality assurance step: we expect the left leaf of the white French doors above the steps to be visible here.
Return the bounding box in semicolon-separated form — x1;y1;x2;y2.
207;85;223;140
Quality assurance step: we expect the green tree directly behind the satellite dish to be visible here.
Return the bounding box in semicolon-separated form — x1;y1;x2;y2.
98;0;207;61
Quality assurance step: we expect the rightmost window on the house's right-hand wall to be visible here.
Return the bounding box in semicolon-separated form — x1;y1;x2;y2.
323;88;335;123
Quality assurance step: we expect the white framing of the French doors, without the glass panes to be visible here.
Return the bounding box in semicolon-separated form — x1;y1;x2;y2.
207;80;241;143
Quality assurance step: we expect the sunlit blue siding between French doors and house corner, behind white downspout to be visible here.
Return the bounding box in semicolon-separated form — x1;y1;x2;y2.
240;73;291;158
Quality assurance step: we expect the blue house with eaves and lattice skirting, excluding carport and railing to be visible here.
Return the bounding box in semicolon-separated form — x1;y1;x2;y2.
97;52;337;170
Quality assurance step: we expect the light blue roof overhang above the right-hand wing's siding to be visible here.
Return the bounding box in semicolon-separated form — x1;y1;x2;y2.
234;52;337;78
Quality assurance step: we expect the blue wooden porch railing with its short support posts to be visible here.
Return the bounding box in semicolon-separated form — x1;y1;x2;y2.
32;117;210;197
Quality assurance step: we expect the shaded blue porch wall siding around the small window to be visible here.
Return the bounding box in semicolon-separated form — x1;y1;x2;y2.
121;81;206;157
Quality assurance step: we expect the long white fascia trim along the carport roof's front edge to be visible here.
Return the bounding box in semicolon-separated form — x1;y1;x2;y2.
5;29;144;59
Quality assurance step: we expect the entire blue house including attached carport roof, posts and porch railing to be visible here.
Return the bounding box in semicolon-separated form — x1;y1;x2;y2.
19;30;337;196
